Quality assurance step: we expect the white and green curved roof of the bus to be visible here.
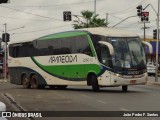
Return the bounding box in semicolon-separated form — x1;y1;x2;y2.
10;27;138;44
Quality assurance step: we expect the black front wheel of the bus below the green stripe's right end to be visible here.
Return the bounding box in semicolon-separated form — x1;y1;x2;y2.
91;75;99;92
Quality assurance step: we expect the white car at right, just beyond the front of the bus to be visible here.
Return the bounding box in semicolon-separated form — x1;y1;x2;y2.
147;62;156;75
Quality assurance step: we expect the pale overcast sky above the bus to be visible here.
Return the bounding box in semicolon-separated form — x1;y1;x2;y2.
0;0;158;42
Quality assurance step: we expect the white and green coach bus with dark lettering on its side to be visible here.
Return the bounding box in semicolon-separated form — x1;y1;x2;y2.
8;27;152;91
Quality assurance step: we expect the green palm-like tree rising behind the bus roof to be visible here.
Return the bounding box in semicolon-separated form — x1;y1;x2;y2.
73;10;106;29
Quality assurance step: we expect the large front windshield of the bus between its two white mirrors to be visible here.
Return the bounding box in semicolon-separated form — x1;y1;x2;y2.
108;37;146;68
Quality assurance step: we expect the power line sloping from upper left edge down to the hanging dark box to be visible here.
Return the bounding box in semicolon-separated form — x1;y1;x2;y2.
0;6;63;21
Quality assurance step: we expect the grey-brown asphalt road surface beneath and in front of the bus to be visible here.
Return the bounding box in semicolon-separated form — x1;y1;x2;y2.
0;76;160;120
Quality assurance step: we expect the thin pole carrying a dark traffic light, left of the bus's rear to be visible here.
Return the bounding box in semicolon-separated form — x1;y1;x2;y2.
4;23;7;80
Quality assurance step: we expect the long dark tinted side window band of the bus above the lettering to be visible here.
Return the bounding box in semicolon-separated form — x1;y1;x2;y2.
9;36;92;57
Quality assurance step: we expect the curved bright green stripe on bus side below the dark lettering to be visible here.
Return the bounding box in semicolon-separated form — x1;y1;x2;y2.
32;57;101;78
